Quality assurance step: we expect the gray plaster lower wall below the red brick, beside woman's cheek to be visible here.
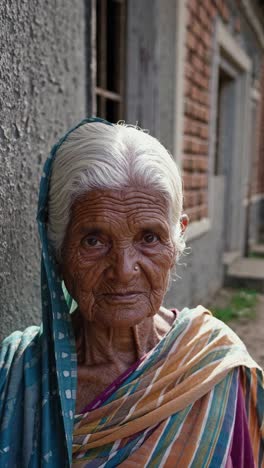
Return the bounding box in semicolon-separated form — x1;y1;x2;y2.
165;176;224;309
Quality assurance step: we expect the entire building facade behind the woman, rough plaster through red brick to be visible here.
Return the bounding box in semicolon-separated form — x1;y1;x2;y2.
0;0;264;336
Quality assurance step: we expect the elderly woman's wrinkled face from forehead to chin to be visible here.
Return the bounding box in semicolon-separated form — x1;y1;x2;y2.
62;187;176;327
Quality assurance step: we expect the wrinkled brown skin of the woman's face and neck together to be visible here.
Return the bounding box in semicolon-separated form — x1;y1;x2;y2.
61;187;187;412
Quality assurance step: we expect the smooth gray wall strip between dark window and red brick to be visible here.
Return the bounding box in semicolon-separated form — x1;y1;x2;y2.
126;0;177;152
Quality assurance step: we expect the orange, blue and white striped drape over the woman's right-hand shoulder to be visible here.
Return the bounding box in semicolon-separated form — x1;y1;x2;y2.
73;306;264;467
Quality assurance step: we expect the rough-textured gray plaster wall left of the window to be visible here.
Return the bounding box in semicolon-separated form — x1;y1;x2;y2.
0;0;88;338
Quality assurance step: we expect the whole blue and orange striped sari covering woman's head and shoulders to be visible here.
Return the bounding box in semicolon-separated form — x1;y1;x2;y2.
0;118;264;468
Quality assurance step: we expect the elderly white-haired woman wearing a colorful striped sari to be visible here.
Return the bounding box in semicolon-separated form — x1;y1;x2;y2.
0;119;264;467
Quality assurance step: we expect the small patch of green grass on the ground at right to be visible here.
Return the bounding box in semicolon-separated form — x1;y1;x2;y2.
212;289;258;322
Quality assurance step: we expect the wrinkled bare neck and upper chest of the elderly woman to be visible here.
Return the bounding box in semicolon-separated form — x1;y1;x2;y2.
72;309;175;412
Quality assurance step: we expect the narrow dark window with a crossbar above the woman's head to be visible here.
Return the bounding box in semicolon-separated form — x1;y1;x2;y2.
95;0;126;122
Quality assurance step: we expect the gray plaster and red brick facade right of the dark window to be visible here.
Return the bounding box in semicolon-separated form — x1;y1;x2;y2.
97;0;264;307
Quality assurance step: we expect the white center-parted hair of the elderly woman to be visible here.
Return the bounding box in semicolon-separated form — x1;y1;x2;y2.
48;122;185;260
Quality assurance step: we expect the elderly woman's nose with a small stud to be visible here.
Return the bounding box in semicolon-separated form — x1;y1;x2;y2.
105;247;139;283
